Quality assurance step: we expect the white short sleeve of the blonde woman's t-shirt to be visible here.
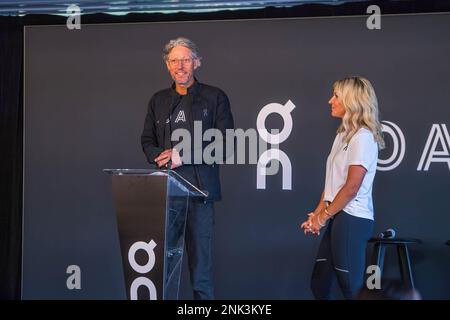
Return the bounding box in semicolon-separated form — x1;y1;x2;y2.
347;132;378;170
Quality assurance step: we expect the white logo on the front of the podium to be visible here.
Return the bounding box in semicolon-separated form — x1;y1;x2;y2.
128;240;157;300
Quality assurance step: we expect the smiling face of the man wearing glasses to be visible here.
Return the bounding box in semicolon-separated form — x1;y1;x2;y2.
166;46;200;87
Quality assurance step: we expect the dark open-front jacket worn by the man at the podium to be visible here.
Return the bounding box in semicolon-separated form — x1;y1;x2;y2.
141;81;234;201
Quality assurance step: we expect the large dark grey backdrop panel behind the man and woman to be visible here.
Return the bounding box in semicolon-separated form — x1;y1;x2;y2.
23;14;450;299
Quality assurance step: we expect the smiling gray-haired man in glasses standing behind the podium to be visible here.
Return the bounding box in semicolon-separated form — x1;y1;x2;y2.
141;37;234;299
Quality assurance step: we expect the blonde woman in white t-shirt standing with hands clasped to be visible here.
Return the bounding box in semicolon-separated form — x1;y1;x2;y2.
301;77;384;299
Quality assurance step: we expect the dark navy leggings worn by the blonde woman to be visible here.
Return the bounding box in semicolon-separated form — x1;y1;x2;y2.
311;211;373;299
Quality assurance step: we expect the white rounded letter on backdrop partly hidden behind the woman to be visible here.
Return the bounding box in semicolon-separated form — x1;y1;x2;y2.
377;121;406;171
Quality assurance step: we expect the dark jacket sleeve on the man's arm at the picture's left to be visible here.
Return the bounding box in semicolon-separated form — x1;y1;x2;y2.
141;97;163;164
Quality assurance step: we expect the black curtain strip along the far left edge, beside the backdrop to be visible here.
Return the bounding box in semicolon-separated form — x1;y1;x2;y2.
0;17;23;300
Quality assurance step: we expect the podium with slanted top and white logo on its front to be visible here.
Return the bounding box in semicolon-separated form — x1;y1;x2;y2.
103;169;207;300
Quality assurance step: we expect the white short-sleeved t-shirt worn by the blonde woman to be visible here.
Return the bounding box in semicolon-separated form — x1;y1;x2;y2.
324;128;378;220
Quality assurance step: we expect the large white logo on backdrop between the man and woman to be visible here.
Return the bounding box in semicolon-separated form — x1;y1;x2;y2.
256;100;295;190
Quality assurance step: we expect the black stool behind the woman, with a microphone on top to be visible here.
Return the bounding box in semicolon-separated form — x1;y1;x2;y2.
369;238;422;289
